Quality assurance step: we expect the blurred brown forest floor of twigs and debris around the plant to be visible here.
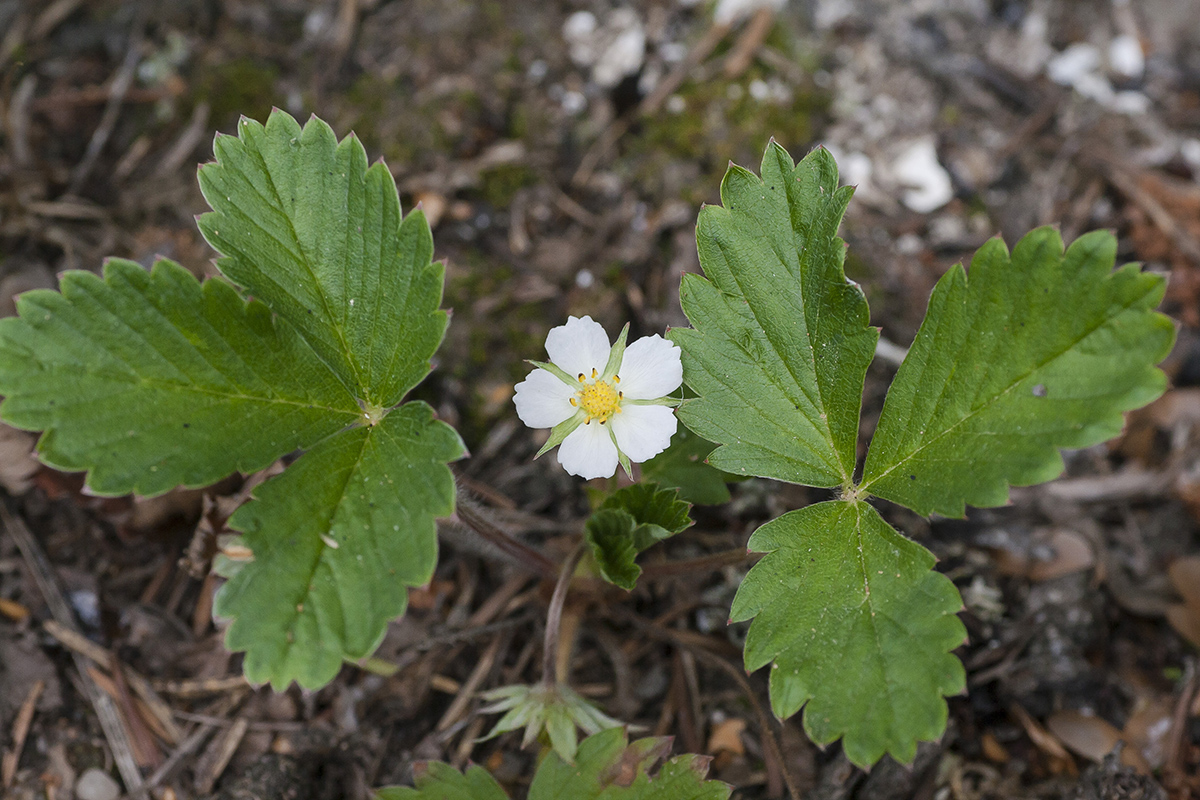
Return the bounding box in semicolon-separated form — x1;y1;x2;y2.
0;0;1200;800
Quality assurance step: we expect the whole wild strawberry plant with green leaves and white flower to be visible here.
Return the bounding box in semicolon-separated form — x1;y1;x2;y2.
0;112;1174;786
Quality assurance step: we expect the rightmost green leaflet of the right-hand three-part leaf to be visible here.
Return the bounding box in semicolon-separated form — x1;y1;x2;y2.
862;228;1175;517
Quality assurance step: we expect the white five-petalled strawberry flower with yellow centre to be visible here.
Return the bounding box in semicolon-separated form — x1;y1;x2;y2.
512;317;683;479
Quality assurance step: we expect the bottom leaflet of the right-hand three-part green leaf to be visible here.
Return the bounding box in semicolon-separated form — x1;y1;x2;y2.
731;500;966;768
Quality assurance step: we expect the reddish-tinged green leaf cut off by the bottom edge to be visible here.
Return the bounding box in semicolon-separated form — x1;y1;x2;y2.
377;728;731;800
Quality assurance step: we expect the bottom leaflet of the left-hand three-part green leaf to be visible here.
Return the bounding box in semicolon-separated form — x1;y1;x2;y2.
214;402;463;688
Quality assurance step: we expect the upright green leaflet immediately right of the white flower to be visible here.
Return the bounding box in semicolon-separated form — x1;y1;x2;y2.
670;142;878;487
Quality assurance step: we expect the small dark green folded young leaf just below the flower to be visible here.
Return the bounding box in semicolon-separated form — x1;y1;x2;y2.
583;483;691;591
